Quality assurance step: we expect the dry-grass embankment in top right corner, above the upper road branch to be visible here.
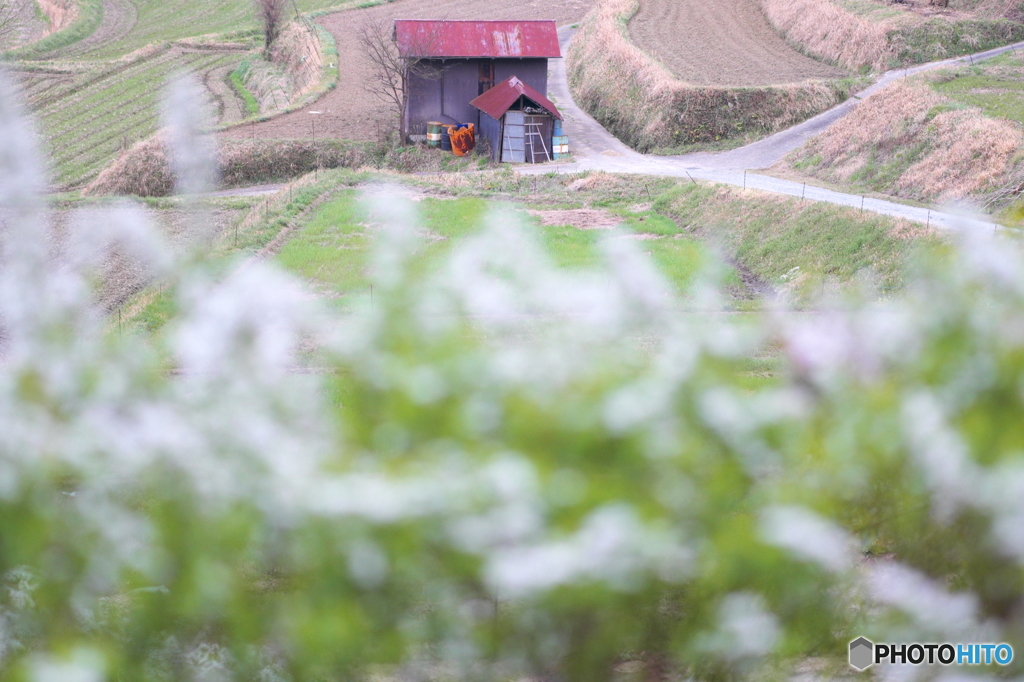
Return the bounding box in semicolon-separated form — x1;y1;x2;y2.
761;0;1024;73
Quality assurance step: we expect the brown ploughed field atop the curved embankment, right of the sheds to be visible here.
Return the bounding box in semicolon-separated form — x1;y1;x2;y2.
629;0;846;87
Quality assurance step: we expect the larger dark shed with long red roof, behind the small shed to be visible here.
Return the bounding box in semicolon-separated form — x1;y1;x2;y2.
394;19;561;152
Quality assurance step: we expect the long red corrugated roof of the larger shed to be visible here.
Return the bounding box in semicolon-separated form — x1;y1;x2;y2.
394;19;562;58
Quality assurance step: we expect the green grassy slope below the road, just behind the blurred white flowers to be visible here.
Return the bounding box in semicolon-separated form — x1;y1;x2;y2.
125;170;939;331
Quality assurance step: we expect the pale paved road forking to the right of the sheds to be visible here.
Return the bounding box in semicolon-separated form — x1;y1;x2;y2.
516;28;1024;230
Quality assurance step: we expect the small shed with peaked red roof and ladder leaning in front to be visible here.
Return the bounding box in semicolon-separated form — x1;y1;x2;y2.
469;76;562;164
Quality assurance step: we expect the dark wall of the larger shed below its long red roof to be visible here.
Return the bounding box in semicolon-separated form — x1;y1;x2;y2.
406;59;548;135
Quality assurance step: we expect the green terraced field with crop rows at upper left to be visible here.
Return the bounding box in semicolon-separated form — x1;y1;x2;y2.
5;0;372;188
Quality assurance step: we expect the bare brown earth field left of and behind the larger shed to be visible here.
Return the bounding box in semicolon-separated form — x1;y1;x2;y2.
221;0;595;140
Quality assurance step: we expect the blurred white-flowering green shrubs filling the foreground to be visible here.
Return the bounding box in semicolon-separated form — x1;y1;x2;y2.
6;66;1024;682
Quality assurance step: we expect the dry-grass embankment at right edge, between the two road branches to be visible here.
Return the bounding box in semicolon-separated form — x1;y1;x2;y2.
784;52;1024;212
